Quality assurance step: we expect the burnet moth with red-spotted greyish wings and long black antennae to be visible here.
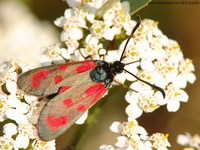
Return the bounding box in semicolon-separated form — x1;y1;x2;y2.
17;16;165;141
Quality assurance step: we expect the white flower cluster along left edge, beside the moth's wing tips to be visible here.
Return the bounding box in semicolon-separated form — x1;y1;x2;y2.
0;61;55;150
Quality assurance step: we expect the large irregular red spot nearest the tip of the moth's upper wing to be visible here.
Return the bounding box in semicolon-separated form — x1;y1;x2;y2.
30;70;49;89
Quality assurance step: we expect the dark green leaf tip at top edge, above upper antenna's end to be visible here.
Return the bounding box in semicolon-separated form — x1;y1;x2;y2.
122;0;151;15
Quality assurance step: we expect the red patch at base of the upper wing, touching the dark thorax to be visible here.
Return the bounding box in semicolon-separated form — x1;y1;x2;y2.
76;61;96;73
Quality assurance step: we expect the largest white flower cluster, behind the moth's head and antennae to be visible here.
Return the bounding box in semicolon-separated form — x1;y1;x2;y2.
48;0;196;119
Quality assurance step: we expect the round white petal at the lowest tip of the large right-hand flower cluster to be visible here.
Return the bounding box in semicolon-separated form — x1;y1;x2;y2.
125;104;143;119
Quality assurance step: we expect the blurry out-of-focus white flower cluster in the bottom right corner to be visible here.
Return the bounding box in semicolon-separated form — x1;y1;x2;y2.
177;133;200;150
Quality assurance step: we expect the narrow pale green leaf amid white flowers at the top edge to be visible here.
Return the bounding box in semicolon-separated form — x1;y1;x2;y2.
96;0;120;19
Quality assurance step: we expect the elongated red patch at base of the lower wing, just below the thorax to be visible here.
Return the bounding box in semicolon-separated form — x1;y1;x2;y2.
85;83;105;97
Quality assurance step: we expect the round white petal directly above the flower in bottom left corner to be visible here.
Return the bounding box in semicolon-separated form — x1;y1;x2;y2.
3;123;17;137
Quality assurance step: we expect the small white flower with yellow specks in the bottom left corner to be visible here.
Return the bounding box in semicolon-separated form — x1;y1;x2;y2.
0;135;14;150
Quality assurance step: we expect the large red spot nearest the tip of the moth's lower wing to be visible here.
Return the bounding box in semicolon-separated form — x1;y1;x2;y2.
46;116;69;131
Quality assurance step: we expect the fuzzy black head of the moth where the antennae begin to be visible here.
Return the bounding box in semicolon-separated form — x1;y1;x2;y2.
110;61;125;75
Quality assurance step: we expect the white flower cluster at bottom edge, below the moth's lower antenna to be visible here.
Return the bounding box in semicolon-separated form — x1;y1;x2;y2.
99;120;171;150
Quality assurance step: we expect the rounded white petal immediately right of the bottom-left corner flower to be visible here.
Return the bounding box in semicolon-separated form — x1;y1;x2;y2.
15;134;29;149
